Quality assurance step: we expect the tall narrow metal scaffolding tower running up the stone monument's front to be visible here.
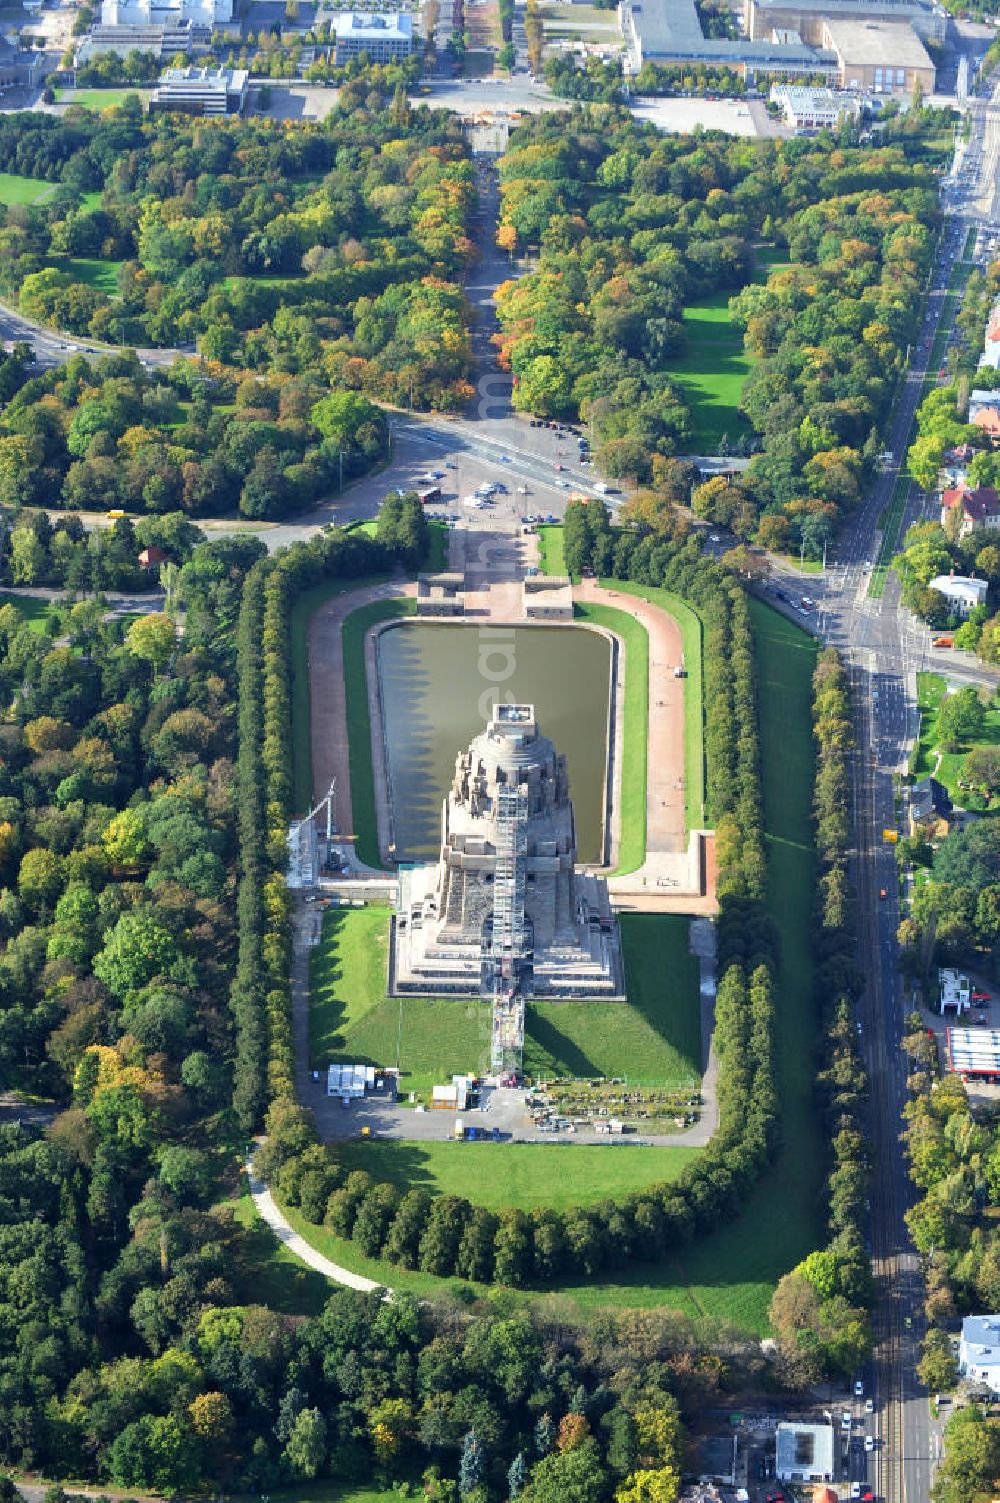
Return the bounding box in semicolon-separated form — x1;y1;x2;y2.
487;785;528;1076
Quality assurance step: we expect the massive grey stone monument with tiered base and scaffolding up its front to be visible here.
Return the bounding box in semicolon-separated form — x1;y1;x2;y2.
389;705;623;1073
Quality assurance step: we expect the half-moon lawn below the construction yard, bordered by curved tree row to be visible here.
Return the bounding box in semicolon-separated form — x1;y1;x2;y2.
337;1139;698;1211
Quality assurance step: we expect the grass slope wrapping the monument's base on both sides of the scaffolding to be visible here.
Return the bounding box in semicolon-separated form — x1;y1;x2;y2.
310;906;701;1094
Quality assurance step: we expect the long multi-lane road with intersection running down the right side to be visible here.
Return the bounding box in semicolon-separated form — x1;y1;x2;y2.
745;70;1000;1503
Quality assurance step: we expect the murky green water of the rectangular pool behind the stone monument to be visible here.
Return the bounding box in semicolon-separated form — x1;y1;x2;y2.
379;621;611;861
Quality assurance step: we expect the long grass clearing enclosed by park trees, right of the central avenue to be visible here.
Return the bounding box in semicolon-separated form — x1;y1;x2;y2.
668;292;753;454
